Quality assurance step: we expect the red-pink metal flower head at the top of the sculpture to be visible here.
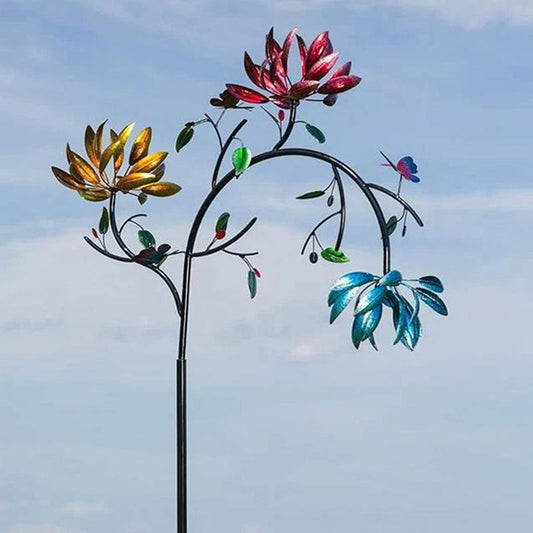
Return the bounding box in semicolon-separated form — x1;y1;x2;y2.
226;28;361;109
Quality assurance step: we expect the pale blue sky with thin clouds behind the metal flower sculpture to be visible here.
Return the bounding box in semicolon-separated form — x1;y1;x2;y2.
0;0;533;533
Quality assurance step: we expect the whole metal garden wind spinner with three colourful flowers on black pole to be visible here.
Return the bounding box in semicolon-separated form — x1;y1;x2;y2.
52;29;447;533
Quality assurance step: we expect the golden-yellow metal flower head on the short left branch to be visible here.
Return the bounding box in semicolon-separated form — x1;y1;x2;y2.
52;121;181;202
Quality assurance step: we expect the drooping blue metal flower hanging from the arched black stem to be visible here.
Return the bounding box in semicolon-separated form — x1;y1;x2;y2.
328;270;448;350
